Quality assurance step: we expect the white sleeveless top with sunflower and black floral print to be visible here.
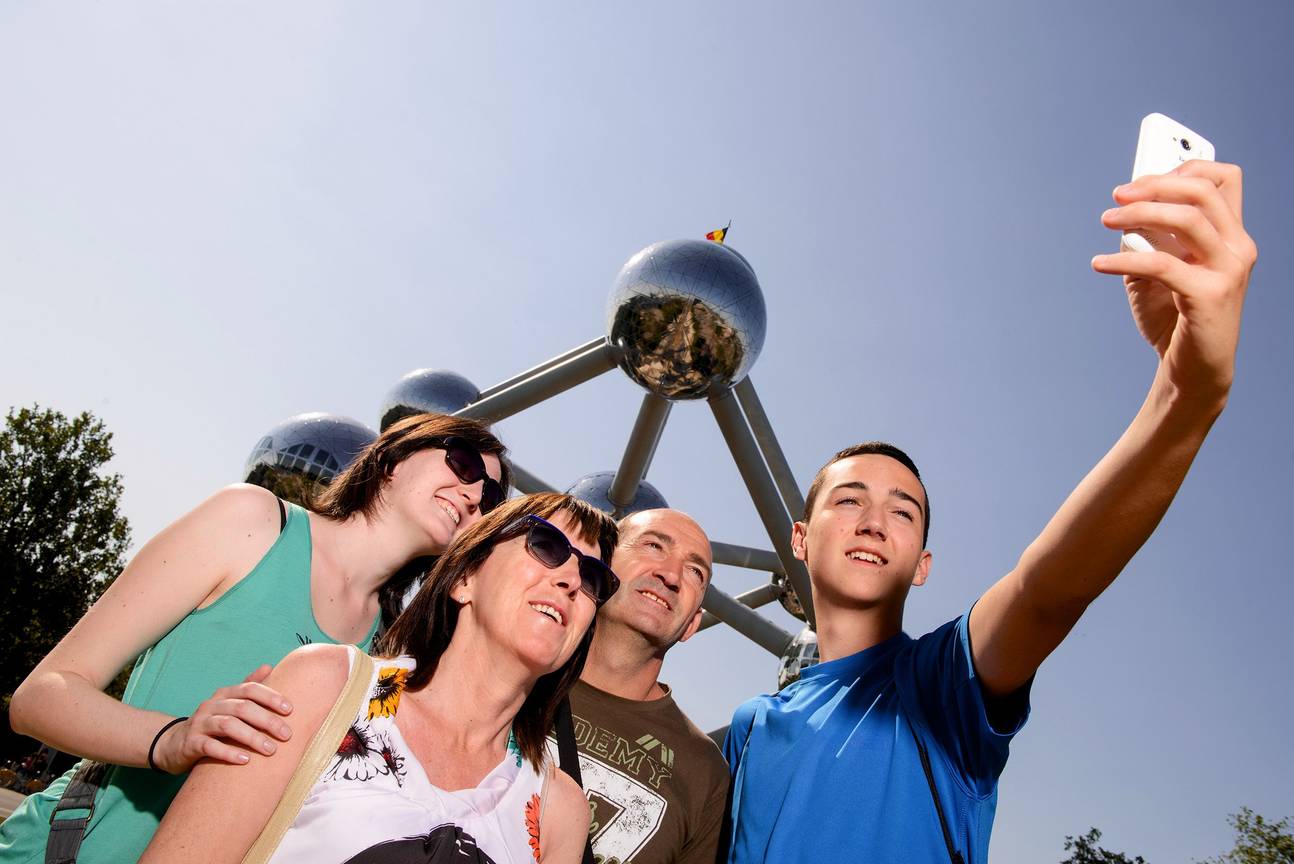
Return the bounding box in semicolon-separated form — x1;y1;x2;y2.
270;648;547;864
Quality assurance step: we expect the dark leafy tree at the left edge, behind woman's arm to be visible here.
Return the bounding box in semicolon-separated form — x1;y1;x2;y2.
0;405;131;708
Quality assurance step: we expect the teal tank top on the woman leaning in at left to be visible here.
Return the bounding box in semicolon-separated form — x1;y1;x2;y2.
0;504;380;864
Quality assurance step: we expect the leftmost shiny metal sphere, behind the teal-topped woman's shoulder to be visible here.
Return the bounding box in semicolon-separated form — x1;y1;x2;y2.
243;413;378;504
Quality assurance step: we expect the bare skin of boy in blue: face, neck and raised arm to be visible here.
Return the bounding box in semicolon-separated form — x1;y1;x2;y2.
795;160;1258;696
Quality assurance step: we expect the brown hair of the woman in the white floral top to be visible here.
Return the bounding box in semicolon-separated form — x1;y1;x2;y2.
375;491;619;770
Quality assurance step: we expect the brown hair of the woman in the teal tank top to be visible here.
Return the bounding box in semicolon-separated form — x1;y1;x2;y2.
311;413;512;625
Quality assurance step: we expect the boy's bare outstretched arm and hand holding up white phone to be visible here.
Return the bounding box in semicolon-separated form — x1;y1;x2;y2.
969;160;1258;696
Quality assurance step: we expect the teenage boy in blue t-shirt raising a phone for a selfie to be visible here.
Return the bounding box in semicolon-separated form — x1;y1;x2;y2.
725;162;1258;864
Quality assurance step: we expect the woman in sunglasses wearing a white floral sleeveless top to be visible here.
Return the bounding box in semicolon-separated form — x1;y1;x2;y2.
142;493;619;864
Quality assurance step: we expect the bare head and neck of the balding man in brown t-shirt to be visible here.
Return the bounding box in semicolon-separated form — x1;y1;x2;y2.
581;510;713;700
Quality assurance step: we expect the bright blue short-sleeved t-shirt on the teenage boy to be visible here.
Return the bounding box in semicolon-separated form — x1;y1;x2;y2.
723;613;1029;864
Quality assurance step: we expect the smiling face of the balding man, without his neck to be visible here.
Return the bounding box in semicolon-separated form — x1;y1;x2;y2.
598;510;713;649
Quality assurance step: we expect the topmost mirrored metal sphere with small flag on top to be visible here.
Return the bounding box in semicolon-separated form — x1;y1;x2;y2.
607;241;767;400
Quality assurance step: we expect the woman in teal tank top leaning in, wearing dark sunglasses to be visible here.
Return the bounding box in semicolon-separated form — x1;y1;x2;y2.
0;414;509;864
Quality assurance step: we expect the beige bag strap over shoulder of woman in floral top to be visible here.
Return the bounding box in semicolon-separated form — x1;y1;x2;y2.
243;645;373;864
